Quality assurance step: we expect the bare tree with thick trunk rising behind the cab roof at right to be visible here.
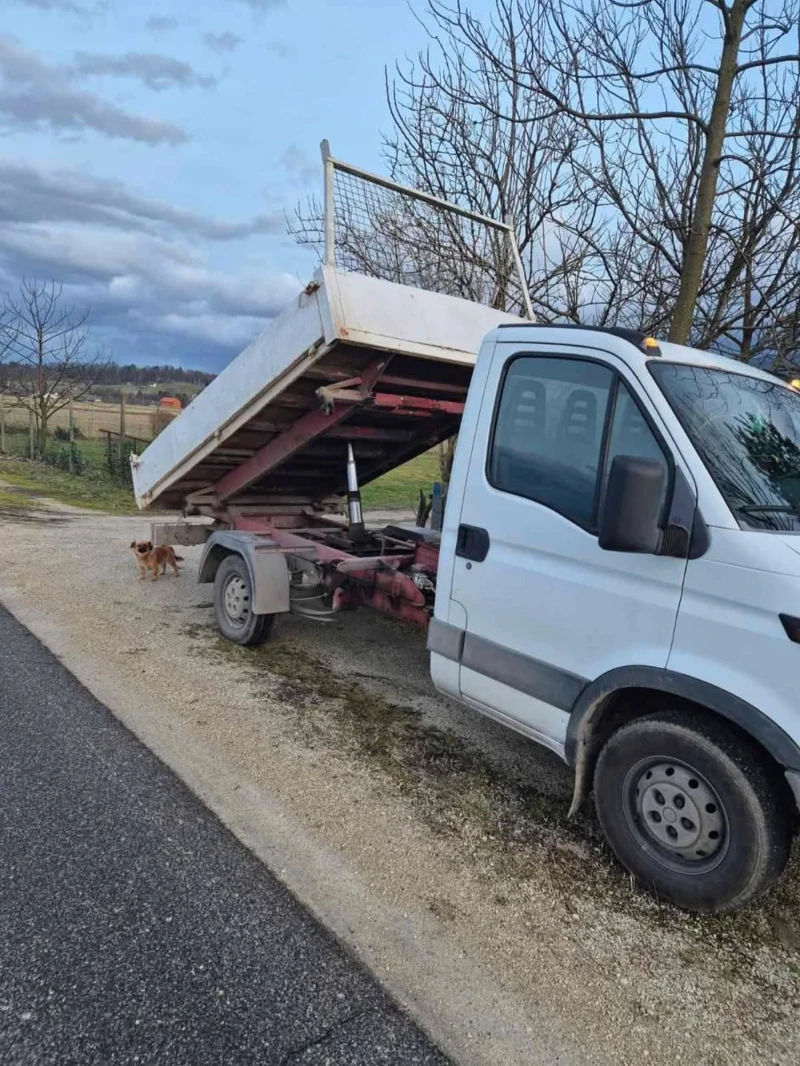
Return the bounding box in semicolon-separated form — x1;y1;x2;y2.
428;0;800;347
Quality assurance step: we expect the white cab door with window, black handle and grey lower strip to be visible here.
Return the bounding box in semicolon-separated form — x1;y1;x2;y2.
451;344;686;750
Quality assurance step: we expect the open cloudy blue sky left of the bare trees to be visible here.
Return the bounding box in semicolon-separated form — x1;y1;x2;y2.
0;0;439;370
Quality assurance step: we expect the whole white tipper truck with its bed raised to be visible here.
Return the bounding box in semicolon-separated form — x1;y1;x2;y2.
133;141;800;911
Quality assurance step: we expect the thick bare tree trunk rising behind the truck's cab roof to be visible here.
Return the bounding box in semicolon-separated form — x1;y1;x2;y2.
669;0;749;344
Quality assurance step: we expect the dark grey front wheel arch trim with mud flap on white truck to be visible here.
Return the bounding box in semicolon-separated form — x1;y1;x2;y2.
564;666;800;814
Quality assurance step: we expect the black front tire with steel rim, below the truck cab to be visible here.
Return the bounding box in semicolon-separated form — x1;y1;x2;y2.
594;710;791;914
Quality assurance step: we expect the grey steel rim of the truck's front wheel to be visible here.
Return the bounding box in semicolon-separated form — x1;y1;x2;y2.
623;758;730;874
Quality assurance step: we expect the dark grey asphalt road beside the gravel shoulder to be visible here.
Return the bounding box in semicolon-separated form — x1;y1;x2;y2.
0;608;446;1066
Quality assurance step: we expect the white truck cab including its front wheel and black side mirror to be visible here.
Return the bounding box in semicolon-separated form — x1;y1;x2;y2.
429;323;800;910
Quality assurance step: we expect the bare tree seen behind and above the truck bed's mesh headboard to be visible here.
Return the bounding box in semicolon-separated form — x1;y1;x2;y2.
289;26;609;321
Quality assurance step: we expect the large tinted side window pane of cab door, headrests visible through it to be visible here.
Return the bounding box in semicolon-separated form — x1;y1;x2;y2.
487;356;615;529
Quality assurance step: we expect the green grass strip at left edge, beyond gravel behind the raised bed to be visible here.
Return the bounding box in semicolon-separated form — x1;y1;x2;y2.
0;454;137;515
